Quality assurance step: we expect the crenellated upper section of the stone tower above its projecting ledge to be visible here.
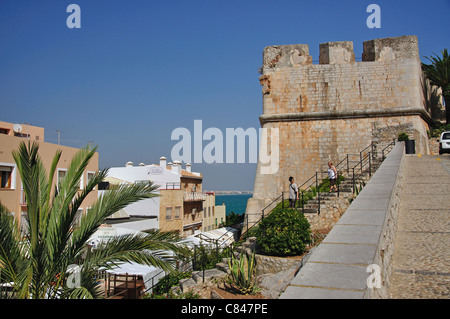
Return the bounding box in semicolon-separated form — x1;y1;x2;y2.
260;36;423;117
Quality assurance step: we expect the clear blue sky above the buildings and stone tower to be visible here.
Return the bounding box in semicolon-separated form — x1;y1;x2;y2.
0;0;450;190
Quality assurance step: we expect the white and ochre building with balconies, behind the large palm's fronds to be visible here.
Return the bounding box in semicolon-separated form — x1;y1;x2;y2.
101;157;205;236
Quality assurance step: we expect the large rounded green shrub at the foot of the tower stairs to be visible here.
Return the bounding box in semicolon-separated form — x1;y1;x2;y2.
256;207;311;257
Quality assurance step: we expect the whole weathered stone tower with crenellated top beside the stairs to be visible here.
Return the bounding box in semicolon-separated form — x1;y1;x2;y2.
247;36;430;223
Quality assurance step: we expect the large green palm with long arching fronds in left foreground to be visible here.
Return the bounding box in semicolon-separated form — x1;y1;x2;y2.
0;142;188;299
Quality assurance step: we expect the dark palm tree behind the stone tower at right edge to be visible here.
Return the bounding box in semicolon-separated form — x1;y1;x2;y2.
422;49;450;124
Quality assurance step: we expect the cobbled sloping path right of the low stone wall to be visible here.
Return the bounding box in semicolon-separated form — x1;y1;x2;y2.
389;155;450;299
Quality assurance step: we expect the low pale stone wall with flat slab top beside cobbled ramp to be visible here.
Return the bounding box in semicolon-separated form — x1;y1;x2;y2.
279;143;404;299
